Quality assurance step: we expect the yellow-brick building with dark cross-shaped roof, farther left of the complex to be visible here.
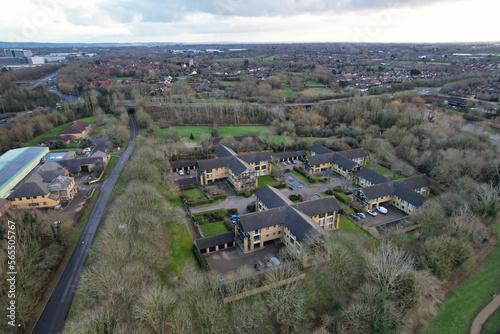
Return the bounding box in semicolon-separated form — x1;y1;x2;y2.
196;146;271;191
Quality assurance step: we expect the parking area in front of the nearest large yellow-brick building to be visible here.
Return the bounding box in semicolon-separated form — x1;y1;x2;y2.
205;243;279;274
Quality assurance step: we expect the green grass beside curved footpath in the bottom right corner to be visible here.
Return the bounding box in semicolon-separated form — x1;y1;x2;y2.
422;223;500;334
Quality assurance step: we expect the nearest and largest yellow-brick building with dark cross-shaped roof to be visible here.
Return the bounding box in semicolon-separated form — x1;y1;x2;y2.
235;186;341;252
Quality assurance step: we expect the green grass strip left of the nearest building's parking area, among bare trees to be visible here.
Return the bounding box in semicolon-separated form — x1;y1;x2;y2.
166;220;194;273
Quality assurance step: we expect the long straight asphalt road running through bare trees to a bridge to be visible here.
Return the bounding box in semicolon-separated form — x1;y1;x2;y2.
33;114;139;334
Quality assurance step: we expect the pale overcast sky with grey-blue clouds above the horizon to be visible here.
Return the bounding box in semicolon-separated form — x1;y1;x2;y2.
0;0;500;43
